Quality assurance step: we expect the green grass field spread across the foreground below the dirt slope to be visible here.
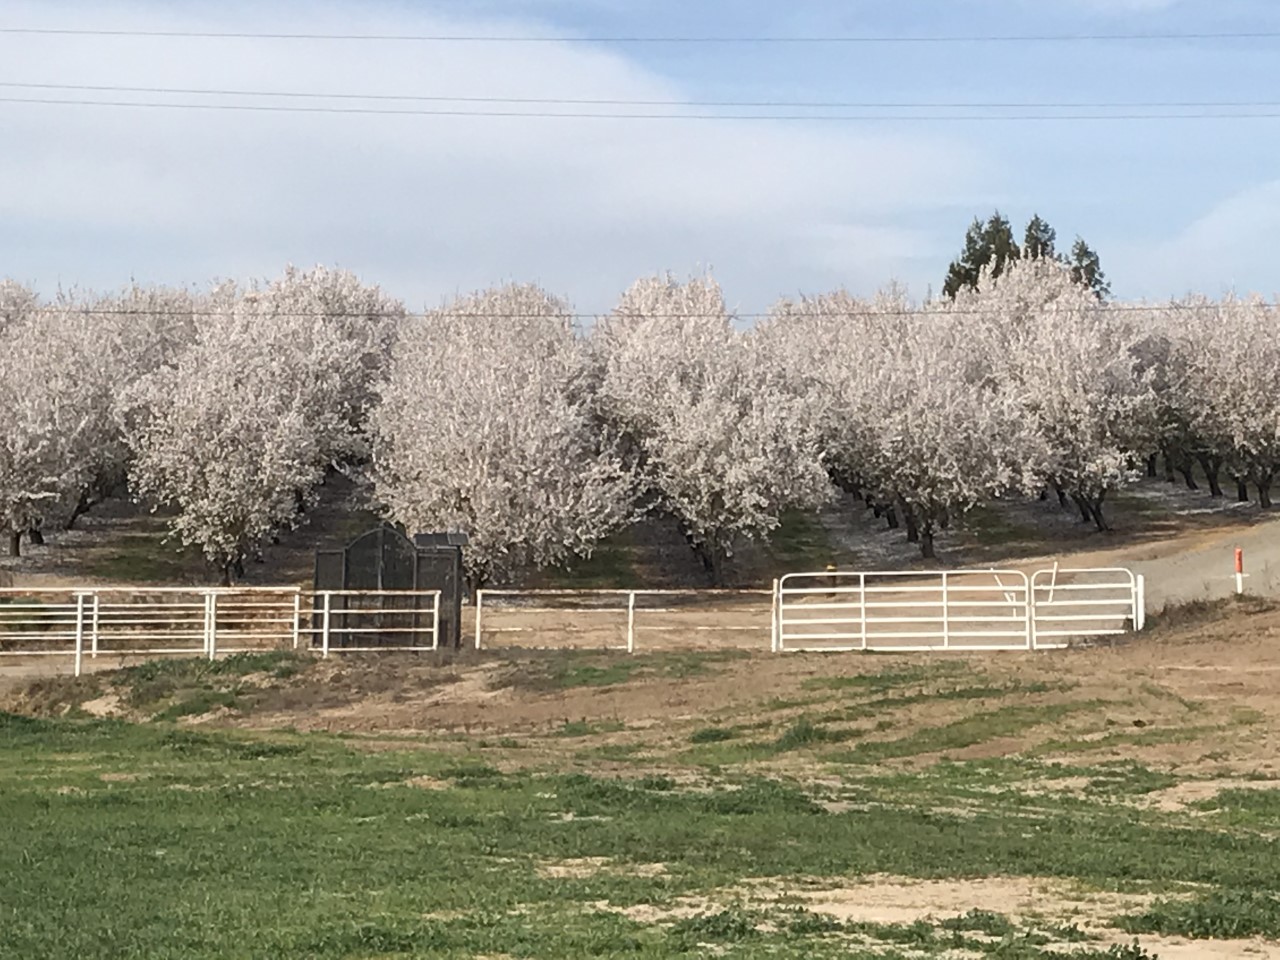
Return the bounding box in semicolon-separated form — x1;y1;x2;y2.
0;634;1280;960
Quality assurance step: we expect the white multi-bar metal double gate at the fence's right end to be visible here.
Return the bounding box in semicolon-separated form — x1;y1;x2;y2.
773;566;1146;653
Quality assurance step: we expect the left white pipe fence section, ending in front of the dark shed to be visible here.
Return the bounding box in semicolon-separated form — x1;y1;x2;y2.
0;588;440;676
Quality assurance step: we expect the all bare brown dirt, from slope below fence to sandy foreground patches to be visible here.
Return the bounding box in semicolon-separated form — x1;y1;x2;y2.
0;602;1280;960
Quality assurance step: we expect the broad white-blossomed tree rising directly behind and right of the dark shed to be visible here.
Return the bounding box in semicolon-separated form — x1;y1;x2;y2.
372;285;635;586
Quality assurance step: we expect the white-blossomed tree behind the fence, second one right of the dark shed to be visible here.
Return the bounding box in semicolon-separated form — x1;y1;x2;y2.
591;276;829;580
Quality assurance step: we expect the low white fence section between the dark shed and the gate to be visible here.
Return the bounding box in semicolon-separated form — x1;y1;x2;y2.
474;590;773;653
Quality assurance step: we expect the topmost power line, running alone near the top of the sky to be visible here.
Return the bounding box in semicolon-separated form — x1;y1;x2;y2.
0;27;1280;45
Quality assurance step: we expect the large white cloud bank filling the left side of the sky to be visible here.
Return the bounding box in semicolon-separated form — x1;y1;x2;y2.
0;0;1000;310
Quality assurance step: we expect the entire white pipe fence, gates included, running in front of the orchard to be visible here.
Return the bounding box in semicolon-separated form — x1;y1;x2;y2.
0;564;1146;676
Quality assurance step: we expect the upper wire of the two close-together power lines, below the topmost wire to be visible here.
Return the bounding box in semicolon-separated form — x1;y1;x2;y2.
0;81;1280;110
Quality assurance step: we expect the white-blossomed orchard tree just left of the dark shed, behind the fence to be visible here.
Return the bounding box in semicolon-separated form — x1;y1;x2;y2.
120;269;402;580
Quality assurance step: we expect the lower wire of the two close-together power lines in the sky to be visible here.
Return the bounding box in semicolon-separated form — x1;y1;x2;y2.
0;97;1280;122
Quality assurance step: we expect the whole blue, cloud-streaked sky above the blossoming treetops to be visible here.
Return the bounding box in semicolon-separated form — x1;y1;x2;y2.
0;0;1280;312
